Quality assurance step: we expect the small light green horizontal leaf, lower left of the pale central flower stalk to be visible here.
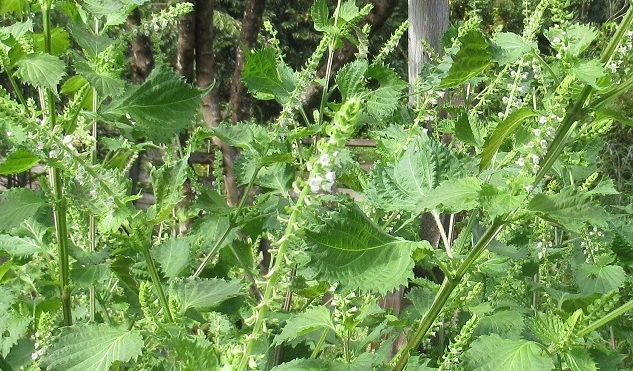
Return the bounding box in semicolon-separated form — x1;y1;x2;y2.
170;278;242;313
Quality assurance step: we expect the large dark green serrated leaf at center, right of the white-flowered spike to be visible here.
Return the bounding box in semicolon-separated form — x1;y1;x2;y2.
305;206;432;293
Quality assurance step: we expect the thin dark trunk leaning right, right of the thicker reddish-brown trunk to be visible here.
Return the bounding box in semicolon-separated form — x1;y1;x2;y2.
230;0;266;122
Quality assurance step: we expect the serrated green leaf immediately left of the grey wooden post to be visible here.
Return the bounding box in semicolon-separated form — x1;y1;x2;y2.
364;65;407;119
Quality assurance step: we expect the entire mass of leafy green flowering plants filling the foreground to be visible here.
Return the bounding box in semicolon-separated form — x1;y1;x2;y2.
0;0;633;370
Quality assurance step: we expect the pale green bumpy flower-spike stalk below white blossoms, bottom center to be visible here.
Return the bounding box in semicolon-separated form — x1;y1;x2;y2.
237;185;310;371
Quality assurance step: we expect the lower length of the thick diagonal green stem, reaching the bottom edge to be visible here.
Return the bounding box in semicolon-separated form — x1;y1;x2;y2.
394;219;504;371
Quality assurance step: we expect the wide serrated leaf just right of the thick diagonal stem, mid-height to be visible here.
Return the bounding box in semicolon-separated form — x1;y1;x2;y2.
527;187;612;232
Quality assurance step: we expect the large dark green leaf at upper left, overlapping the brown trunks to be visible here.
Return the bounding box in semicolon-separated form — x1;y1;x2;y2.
102;65;209;143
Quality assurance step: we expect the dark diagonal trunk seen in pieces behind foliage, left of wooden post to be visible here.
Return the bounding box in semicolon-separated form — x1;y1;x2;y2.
303;0;398;112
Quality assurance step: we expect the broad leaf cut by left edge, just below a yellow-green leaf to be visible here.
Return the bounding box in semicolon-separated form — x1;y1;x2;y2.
0;188;46;231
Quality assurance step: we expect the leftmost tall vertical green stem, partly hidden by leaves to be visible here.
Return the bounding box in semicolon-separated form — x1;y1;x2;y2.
42;0;72;326
